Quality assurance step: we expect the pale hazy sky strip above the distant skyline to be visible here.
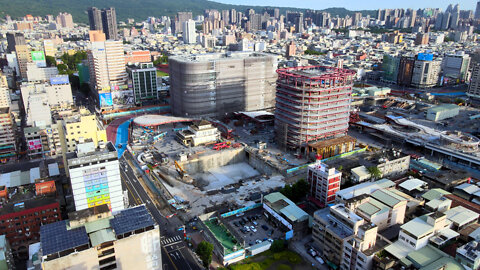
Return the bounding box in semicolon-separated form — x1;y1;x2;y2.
214;0;477;10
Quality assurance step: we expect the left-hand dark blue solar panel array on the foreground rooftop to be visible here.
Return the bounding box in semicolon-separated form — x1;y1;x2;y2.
40;220;89;255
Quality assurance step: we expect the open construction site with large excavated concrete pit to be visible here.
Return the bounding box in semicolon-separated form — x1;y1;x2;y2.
127;115;307;216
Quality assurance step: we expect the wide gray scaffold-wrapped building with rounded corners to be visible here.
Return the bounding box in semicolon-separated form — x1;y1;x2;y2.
168;52;277;118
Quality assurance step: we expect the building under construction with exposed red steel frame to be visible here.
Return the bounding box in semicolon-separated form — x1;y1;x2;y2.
275;66;355;152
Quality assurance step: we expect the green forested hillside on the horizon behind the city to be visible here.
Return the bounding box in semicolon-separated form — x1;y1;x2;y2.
0;0;376;23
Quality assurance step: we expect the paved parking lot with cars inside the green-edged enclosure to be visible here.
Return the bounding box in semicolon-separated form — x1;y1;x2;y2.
225;209;285;247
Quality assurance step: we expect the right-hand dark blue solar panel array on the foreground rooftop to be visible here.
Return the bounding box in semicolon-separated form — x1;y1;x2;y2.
110;206;155;235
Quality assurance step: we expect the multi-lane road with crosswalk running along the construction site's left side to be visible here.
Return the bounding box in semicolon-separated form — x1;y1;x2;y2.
120;155;202;270
